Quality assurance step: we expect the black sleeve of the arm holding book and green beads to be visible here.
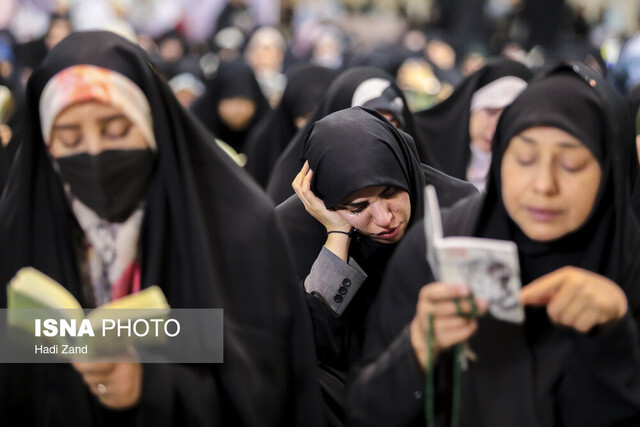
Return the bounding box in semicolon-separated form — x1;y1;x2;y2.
348;221;440;425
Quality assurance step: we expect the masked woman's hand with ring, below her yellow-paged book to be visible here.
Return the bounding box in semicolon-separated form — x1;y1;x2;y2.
71;354;142;409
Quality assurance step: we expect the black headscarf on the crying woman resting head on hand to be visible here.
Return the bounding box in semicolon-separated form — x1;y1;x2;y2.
304;107;424;217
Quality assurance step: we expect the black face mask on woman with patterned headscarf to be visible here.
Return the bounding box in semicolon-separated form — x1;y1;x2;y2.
57;149;155;222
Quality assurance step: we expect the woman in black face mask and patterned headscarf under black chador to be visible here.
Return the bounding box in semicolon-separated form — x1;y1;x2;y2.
0;32;319;426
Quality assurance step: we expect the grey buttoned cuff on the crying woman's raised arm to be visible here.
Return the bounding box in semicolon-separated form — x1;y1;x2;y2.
304;246;367;316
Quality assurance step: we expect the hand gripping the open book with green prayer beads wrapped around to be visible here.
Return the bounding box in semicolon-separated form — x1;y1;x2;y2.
410;282;488;370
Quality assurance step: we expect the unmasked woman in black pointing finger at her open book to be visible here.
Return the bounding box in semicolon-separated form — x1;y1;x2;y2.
349;64;640;426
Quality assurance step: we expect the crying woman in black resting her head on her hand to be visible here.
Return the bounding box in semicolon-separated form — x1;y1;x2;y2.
276;107;475;425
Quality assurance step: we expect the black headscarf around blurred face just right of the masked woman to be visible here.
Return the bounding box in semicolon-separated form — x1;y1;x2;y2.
191;58;271;153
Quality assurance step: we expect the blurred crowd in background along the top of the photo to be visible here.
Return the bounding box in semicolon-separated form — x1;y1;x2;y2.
0;0;640;155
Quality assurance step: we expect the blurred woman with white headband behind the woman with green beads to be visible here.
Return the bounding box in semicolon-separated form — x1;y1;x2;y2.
415;60;532;191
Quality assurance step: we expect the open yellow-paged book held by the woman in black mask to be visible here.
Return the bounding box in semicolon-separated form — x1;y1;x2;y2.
7;267;170;355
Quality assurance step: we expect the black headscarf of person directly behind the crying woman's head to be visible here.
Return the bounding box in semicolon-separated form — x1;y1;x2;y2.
267;67;428;204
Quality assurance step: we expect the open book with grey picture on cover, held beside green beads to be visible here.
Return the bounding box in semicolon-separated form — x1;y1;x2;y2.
424;185;524;323
